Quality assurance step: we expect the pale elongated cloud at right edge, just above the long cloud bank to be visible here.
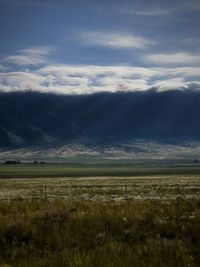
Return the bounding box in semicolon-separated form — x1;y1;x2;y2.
144;52;200;65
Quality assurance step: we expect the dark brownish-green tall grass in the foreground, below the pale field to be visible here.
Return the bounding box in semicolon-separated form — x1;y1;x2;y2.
0;199;200;267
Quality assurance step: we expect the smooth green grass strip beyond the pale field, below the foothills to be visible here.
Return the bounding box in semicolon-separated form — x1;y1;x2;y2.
0;161;200;178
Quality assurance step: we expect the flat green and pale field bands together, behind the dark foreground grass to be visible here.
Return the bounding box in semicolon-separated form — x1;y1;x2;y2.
0;161;200;201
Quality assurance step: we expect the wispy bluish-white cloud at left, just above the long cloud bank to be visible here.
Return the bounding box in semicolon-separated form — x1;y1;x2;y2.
1;47;52;66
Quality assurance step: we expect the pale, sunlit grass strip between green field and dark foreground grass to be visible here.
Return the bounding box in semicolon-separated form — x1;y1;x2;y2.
0;175;200;201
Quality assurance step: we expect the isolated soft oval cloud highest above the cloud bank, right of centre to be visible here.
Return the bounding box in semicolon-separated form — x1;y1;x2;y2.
80;31;153;49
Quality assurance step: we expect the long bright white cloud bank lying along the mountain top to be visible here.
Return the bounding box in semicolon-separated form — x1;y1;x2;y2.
0;64;200;94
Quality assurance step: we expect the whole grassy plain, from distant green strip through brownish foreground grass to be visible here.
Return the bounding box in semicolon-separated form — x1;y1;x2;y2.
0;162;200;267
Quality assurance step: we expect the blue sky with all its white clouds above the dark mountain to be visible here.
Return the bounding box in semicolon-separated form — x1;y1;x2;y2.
0;0;200;94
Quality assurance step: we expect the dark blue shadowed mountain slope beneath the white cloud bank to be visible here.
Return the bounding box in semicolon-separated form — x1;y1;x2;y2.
0;90;200;147
